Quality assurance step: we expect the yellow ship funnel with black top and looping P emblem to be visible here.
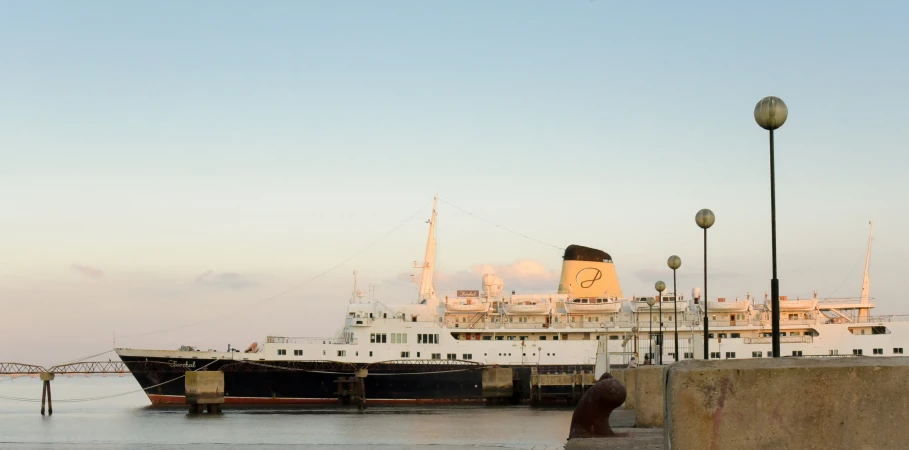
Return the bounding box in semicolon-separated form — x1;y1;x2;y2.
559;245;622;297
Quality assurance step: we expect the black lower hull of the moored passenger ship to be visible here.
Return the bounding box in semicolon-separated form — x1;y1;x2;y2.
121;356;593;405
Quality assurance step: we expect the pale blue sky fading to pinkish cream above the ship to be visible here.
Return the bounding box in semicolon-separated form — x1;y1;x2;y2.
0;0;909;364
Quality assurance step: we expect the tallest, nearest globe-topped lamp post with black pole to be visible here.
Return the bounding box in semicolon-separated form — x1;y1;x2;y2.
754;96;789;358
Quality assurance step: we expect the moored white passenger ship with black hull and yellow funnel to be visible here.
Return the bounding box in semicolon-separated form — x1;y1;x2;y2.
115;196;909;405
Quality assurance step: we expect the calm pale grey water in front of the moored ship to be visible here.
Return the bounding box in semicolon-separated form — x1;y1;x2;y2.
0;376;571;450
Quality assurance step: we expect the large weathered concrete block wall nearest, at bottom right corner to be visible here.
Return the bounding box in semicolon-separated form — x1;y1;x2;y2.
664;357;909;450
